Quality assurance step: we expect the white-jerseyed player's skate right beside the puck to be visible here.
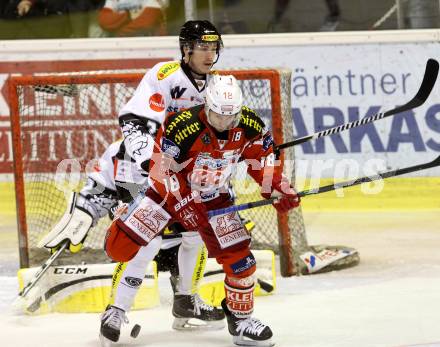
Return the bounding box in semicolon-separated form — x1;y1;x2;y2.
99;305;128;347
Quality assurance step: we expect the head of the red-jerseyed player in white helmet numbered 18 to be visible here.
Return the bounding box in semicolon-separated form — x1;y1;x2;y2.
205;75;243;131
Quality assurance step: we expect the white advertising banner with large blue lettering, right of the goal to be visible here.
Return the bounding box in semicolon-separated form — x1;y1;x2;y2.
219;42;440;177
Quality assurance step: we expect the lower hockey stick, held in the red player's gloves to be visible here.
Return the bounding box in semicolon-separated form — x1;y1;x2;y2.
208;156;440;218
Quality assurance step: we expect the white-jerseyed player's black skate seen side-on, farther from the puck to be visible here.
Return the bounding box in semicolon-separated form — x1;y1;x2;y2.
173;294;225;330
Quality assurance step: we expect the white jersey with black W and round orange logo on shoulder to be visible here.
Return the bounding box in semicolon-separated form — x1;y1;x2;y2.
119;61;206;124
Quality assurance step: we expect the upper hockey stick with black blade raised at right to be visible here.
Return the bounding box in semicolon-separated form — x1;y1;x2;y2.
275;59;439;152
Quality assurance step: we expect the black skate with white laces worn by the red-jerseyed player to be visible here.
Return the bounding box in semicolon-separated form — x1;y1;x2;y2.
222;299;275;347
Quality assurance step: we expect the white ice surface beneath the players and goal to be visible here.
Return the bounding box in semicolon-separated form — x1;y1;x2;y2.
0;211;440;347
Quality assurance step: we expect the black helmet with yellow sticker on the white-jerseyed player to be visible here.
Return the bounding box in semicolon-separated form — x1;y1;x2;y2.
179;20;223;57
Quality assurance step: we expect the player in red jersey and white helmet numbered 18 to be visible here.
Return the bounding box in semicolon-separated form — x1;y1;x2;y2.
105;76;299;346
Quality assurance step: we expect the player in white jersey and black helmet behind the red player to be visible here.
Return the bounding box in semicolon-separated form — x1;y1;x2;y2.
108;21;229;340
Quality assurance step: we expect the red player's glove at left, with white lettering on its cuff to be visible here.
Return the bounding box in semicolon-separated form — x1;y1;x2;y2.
168;190;210;230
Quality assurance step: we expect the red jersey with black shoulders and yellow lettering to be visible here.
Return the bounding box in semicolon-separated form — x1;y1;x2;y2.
150;105;281;202
